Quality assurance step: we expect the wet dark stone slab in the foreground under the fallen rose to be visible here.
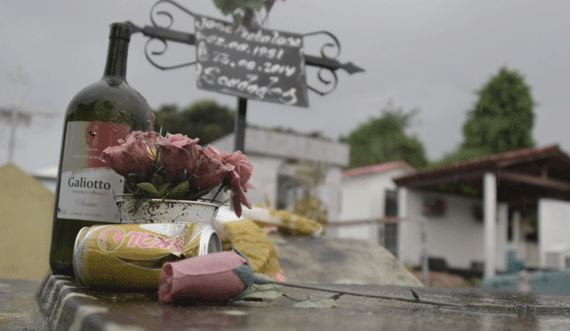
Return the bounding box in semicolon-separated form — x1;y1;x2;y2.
24;275;570;331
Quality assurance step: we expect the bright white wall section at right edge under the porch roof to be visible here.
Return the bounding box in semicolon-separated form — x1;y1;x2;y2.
538;199;570;268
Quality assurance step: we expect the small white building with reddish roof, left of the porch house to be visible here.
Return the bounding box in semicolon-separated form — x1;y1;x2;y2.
327;161;416;256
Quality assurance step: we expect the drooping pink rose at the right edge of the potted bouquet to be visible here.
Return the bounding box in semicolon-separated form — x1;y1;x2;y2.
221;151;255;217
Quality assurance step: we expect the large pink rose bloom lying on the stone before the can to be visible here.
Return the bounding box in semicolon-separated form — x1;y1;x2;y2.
158;252;253;303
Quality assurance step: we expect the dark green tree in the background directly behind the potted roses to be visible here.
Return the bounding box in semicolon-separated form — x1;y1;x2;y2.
154;100;234;145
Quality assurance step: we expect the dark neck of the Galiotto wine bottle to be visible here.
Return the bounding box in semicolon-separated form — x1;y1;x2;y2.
103;24;131;80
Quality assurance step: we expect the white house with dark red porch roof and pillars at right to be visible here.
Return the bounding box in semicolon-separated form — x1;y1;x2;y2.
394;145;570;278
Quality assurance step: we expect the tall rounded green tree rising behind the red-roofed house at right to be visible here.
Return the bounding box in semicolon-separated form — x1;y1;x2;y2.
437;67;535;165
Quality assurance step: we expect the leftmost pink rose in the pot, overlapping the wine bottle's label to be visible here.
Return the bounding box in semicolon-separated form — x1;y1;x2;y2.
101;131;159;177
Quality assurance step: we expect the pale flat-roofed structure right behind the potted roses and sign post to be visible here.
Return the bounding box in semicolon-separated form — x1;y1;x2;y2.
210;128;350;222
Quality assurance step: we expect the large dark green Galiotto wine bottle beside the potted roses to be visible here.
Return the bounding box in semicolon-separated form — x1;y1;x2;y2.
50;23;154;276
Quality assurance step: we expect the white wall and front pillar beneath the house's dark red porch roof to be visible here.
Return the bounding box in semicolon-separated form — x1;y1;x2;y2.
400;190;508;271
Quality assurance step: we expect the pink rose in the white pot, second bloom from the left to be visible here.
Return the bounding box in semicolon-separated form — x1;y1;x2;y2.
156;134;200;177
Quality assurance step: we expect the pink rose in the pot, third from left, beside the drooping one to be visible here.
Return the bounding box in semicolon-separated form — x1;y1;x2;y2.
194;146;234;190
